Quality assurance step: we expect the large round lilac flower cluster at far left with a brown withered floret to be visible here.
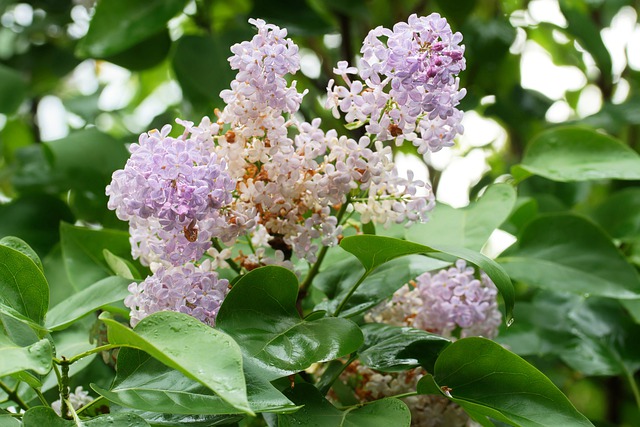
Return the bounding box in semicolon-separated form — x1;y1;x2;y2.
106;125;235;265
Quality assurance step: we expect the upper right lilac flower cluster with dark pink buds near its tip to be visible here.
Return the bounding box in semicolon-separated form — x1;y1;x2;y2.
327;13;466;154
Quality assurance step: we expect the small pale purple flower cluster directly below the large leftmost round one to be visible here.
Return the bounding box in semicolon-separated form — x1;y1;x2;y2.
124;262;229;326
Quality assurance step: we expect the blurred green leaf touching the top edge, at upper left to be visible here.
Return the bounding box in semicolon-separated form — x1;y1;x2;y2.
77;0;187;58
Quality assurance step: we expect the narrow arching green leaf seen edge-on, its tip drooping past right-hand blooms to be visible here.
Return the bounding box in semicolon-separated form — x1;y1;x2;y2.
340;235;515;322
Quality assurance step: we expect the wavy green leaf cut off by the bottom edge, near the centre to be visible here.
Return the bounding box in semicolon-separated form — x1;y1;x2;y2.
278;383;411;427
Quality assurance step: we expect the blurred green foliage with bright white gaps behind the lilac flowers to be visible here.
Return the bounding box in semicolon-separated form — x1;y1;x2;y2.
0;0;640;426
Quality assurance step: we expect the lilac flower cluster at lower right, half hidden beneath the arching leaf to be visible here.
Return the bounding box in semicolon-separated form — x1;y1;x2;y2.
368;259;501;338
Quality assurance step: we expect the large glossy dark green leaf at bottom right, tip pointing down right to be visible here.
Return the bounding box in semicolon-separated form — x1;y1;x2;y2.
418;337;592;427
